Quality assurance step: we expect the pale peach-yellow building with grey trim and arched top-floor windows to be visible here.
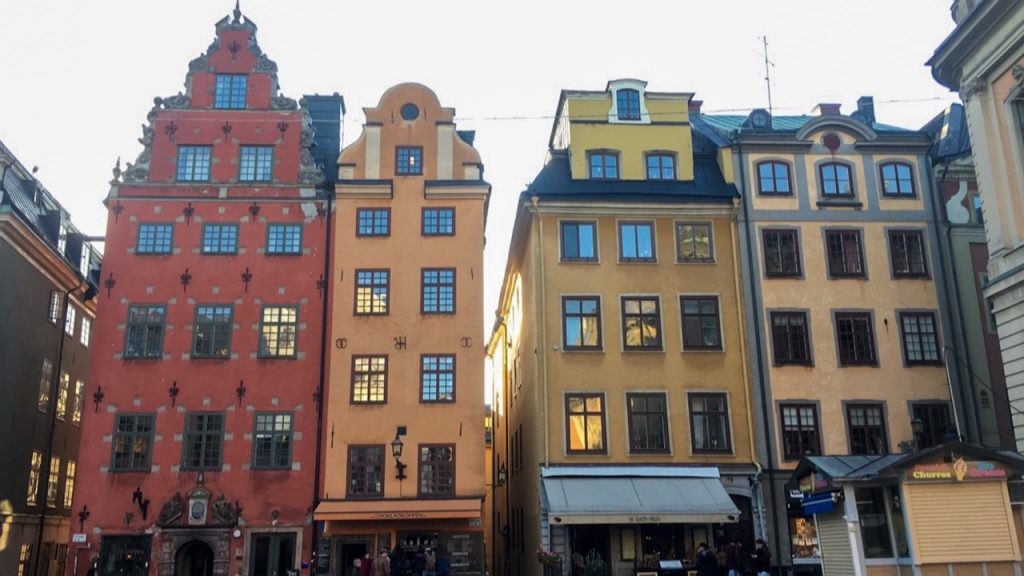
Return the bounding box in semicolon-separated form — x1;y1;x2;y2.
694;97;963;566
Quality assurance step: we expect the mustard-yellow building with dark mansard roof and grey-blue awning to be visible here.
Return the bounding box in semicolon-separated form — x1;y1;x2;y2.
487;80;761;576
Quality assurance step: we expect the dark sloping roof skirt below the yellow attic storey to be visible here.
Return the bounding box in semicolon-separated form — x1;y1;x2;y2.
523;151;739;203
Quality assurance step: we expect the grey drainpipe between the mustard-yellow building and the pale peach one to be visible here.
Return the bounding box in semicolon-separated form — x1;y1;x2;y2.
736;138;788;576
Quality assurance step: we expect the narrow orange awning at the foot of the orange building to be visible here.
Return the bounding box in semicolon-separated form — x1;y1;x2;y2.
313;498;481;521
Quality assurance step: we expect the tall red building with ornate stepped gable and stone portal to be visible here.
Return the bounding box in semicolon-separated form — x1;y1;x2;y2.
68;7;343;576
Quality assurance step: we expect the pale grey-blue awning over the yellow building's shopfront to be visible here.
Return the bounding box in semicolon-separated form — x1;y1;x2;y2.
543;469;739;524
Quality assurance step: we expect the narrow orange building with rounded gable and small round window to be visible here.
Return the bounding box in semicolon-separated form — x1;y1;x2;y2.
315;84;490;574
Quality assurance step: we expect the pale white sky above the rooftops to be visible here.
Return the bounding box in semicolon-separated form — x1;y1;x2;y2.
0;0;956;329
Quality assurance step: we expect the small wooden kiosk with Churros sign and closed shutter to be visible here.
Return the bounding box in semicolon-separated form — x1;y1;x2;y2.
791;443;1024;576
